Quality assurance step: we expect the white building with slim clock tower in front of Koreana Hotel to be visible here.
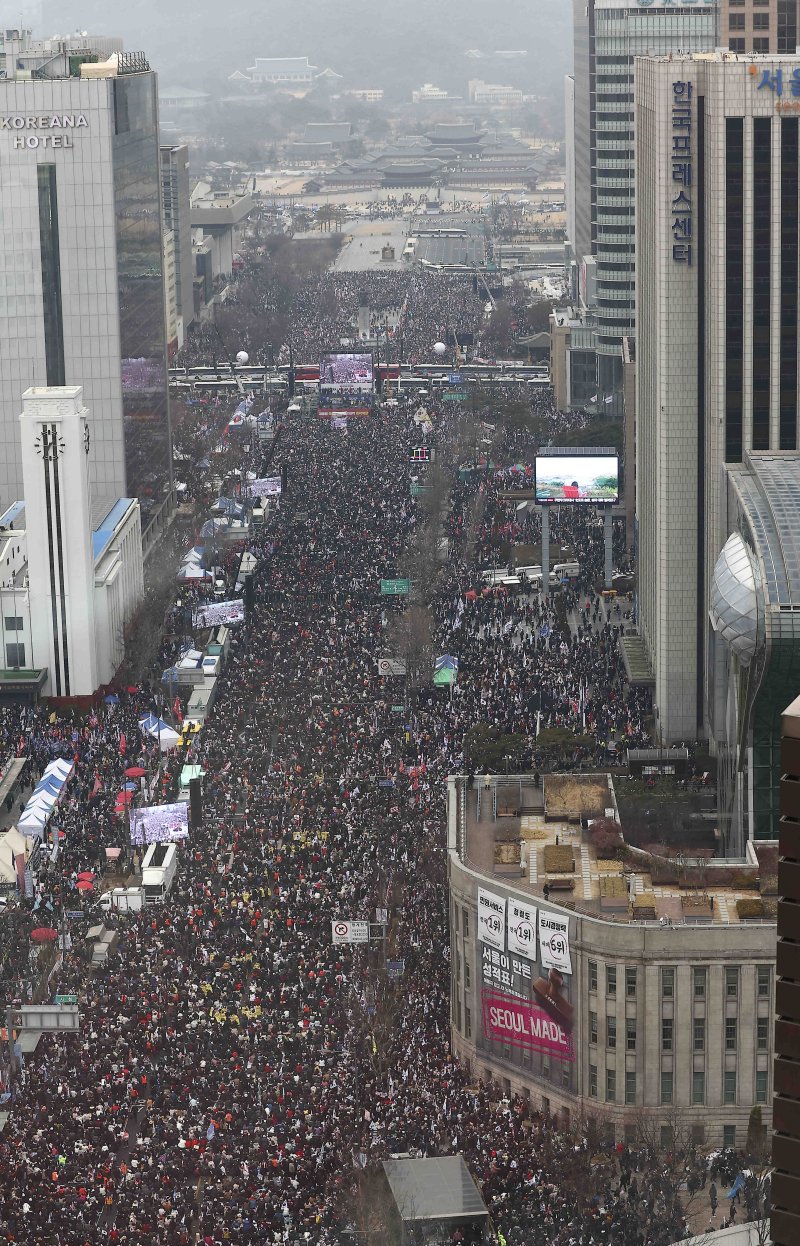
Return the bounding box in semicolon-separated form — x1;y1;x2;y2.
0;385;143;698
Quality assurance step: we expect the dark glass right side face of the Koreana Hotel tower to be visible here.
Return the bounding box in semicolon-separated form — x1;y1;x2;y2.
113;74;172;531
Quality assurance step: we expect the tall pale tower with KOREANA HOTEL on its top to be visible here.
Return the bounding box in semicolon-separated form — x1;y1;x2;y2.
0;37;173;548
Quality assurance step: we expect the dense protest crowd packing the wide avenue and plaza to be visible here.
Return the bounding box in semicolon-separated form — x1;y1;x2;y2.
0;265;752;1246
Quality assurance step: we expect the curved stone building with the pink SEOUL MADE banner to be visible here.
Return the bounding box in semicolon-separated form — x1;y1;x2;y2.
449;775;775;1148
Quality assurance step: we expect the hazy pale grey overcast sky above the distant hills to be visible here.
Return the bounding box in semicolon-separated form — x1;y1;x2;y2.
38;0;572;96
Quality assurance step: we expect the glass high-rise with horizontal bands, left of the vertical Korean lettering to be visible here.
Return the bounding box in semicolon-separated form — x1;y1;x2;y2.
571;0;717;403
